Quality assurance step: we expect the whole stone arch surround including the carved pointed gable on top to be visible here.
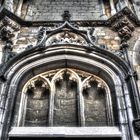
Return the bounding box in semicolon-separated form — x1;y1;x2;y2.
0;22;139;140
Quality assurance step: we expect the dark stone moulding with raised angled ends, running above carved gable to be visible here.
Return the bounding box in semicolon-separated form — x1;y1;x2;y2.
0;7;140;27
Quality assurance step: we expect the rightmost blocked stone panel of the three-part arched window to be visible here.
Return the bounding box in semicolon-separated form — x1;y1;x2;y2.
83;82;107;126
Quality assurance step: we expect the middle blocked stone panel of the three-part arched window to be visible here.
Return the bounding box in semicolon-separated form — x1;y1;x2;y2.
54;79;78;126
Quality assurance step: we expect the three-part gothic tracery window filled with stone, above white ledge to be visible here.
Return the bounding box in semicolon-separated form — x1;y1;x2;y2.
18;68;114;127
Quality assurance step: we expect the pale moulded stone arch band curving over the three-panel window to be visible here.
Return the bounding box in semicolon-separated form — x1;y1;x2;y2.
2;45;138;139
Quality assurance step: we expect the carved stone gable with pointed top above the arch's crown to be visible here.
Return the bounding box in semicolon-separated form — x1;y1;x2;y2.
37;21;96;49
